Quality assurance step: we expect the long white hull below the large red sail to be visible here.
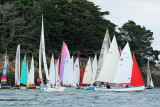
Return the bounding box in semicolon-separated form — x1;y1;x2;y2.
94;86;145;92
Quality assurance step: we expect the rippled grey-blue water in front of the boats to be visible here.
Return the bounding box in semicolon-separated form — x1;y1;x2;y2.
0;89;160;107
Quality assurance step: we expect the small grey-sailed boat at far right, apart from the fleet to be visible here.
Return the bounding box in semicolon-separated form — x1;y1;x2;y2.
146;60;154;89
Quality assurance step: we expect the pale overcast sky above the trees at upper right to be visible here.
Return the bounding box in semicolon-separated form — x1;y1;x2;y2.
89;0;160;50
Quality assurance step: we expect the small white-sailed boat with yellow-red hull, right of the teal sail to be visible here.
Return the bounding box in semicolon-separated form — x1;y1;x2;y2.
27;56;36;89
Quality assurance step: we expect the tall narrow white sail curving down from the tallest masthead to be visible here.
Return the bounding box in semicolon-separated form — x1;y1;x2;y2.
41;15;49;80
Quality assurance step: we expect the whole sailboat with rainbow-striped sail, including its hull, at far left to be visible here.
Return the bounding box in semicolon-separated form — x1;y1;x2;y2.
1;52;11;89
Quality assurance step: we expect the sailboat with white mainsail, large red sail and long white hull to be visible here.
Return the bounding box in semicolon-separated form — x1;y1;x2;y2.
95;43;144;91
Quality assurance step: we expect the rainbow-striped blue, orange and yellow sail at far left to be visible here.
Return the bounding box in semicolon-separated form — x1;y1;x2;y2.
1;52;8;85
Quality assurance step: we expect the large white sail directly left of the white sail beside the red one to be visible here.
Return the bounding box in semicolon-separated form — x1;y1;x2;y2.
96;36;120;83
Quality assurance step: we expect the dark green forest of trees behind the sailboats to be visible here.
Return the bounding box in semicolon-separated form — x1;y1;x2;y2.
0;0;160;66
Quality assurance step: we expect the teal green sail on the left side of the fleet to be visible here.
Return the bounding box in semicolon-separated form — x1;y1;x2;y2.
20;55;27;84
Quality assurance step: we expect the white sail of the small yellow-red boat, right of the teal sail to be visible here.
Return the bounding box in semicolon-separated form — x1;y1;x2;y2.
27;56;34;84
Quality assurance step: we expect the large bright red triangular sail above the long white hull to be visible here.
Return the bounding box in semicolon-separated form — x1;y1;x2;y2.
131;56;145;86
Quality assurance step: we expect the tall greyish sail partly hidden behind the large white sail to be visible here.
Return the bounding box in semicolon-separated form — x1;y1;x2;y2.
96;30;111;79
